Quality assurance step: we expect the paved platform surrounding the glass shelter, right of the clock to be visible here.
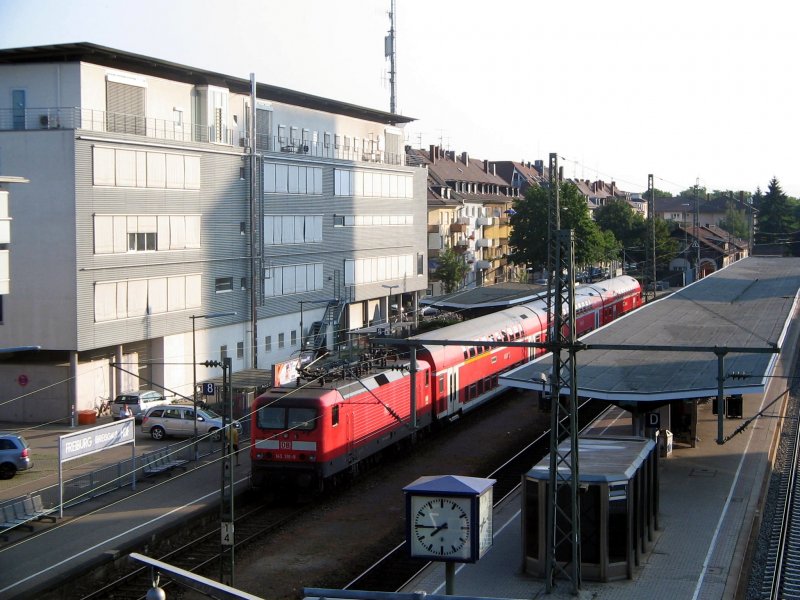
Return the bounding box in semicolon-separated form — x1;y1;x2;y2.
401;380;783;600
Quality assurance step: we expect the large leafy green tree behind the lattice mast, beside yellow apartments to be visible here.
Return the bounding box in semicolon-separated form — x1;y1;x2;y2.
509;181;619;266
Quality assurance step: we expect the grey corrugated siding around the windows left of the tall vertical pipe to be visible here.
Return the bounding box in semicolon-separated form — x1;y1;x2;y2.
75;136;249;352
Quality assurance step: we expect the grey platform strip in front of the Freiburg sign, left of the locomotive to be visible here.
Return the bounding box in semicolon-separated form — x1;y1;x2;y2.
0;432;250;600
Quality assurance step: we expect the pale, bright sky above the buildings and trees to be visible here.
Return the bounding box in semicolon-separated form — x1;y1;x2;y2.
0;0;800;198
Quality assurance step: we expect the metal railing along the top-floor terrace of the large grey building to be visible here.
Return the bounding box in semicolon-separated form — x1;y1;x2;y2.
0;107;405;165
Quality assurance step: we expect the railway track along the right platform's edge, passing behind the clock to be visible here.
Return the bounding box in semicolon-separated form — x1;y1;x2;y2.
344;401;607;592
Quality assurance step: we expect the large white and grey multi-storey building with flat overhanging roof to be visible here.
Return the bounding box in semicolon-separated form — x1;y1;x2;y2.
0;43;427;421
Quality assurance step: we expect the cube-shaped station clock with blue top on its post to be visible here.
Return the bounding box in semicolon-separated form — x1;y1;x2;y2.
403;475;495;595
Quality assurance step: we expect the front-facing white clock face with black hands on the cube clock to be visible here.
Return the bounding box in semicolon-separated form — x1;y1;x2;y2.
411;496;472;559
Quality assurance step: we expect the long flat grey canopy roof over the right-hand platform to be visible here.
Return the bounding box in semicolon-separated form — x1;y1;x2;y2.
500;257;800;406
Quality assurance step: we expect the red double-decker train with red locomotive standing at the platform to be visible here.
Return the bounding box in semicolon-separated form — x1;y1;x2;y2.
250;276;642;490
